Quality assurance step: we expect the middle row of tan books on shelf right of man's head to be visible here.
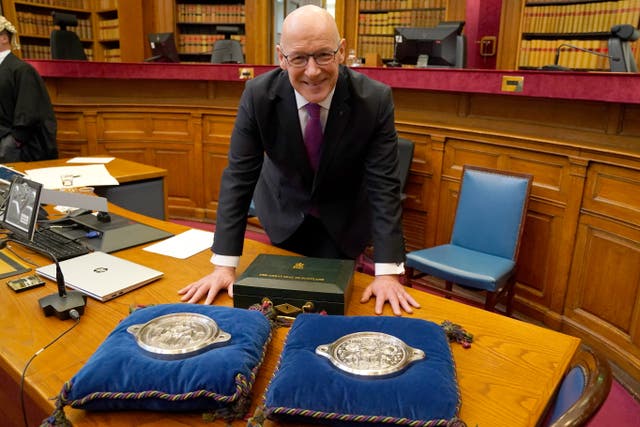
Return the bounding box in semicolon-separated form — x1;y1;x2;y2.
358;10;444;34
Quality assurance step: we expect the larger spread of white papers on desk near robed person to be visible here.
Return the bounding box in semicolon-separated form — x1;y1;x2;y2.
26;164;119;189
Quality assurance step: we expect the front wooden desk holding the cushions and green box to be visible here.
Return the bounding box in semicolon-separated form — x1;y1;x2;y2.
0;207;580;427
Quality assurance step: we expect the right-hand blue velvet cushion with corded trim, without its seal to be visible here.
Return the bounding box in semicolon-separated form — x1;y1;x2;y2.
264;314;464;426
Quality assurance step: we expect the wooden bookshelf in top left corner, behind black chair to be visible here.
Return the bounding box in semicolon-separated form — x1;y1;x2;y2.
2;0;144;62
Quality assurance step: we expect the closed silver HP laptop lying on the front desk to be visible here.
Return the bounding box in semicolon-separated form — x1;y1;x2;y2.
36;252;163;302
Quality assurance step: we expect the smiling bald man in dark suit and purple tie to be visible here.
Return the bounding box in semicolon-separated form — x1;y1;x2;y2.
178;6;419;315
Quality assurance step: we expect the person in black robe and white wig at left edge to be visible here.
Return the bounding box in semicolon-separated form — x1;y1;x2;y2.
0;16;58;163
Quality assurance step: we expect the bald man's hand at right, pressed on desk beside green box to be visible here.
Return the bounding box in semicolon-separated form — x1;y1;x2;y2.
360;274;420;316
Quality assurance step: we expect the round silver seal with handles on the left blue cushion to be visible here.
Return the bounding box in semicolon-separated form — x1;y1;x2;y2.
127;313;231;359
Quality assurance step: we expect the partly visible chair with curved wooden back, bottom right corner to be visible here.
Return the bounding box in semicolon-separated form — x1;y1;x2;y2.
542;346;611;427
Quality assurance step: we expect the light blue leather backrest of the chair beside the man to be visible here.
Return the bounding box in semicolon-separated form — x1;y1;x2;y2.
451;166;533;261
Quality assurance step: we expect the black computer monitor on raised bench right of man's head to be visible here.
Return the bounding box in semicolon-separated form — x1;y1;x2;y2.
391;21;466;68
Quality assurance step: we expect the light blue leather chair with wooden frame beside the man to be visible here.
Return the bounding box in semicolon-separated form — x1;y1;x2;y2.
405;166;532;316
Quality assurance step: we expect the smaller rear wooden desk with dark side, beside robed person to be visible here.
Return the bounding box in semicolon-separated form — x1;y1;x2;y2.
8;158;168;219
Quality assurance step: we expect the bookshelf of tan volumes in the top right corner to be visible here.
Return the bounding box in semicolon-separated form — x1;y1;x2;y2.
518;0;640;71
